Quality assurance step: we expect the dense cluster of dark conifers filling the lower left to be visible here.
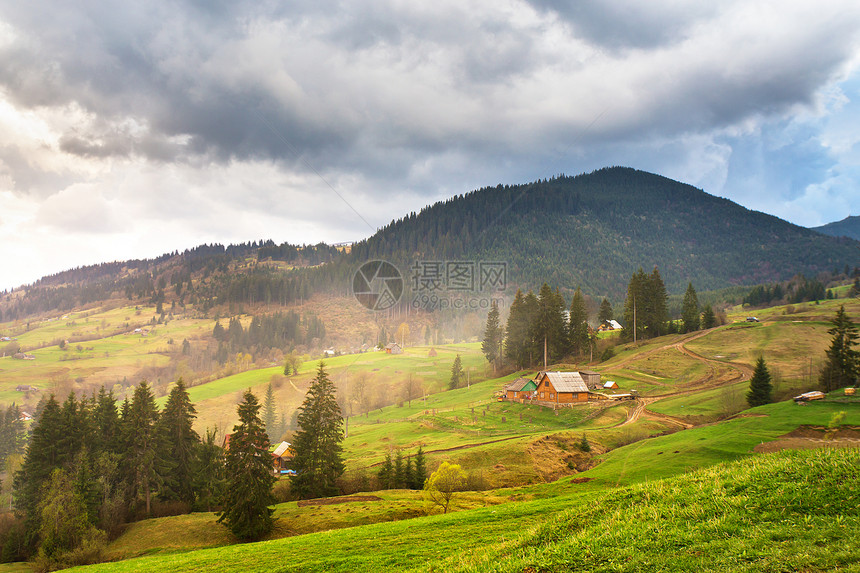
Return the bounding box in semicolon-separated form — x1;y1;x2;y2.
2;379;224;564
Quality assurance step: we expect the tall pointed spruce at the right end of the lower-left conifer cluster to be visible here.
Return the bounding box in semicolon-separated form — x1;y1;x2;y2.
158;378;200;506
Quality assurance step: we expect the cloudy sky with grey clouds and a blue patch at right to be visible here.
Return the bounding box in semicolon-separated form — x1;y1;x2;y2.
0;0;860;289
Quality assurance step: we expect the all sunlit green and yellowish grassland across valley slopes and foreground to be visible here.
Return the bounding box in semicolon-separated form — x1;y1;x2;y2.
0;292;860;572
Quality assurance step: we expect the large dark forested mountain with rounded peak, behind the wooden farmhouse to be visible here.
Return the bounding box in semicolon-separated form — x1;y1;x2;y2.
349;167;860;297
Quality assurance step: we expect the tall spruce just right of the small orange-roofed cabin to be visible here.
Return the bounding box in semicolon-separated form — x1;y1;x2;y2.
291;361;344;499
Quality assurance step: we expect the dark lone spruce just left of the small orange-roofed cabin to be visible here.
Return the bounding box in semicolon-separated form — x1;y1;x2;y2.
218;390;276;540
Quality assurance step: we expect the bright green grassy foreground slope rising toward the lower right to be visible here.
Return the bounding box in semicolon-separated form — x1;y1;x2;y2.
65;449;860;572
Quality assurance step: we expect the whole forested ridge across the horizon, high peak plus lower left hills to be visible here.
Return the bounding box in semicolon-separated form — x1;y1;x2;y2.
0;167;860;321
